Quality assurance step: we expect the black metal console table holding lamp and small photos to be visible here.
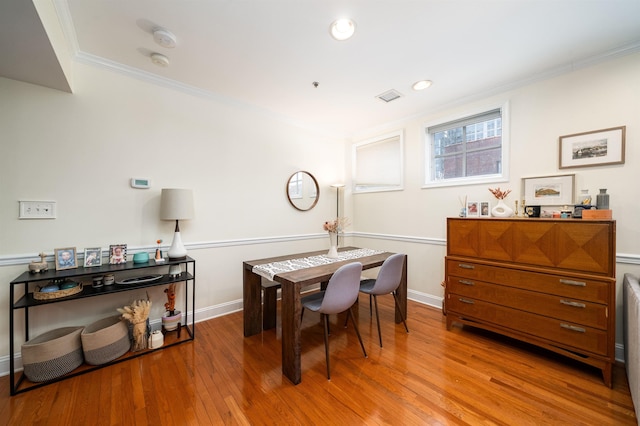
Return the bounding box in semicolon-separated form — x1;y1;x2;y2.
9;257;196;395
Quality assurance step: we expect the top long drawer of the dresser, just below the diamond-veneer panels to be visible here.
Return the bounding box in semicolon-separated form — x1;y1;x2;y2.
446;258;615;305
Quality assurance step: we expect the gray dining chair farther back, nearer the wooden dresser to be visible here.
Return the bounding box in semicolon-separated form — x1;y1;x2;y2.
360;253;409;347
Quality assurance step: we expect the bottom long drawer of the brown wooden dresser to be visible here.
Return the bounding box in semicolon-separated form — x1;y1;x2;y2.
446;294;612;356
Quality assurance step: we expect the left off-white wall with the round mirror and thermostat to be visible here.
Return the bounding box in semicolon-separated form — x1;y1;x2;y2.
0;64;344;362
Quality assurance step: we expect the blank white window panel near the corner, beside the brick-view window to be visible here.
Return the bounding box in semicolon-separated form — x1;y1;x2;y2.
353;131;403;193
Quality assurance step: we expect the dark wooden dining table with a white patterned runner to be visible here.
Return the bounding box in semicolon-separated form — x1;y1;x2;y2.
242;247;407;385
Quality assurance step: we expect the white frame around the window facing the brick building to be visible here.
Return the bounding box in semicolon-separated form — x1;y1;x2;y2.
422;101;510;188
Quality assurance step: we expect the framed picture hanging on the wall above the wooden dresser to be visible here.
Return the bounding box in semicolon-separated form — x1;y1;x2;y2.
559;126;626;169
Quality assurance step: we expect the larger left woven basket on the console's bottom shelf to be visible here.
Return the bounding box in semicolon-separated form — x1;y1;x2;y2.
22;327;84;382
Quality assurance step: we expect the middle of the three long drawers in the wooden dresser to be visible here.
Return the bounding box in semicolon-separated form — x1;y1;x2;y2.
447;276;608;330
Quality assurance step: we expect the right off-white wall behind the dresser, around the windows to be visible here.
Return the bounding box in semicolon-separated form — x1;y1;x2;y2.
347;54;640;360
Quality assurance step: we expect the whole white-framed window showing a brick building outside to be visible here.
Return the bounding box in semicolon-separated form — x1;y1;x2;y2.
425;104;508;186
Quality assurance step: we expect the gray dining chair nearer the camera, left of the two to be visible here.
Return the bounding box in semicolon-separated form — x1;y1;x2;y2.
300;262;367;380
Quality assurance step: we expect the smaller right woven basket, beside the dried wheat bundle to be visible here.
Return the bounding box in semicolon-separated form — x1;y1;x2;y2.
80;315;131;365
